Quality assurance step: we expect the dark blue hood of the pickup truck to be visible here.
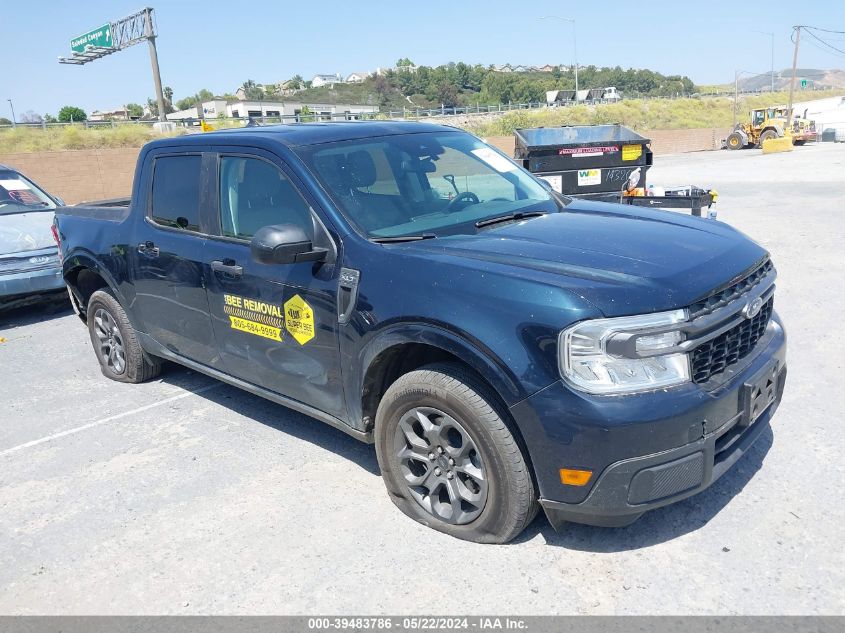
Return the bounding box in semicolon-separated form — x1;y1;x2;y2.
407;201;768;316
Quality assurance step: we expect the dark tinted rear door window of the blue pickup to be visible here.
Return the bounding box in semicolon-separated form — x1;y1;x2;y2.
152;155;202;231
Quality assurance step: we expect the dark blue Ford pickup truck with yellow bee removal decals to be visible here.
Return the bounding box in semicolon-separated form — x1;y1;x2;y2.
56;122;786;542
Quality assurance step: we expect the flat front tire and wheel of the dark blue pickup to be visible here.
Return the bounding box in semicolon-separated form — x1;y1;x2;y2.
375;363;539;543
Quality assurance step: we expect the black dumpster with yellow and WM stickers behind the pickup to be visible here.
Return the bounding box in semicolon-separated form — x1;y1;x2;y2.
514;125;653;200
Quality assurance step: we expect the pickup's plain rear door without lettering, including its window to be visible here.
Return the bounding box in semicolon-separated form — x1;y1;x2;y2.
129;148;220;366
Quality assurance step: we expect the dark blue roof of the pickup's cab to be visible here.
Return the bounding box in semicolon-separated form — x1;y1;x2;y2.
151;121;458;147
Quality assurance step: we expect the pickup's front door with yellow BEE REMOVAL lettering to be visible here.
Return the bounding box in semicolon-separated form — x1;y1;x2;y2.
205;150;345;419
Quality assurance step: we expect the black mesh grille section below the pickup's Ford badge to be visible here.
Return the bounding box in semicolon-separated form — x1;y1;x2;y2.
691;297;775;383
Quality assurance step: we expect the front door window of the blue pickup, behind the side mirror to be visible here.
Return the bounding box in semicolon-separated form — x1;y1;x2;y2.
220;156;314;239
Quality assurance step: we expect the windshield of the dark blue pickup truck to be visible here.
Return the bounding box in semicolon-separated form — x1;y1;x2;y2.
300;132;562;239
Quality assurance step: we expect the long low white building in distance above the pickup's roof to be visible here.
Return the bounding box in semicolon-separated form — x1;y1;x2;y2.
167;99;378;123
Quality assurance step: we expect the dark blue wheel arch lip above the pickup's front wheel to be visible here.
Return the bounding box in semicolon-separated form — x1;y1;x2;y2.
344;322;530;428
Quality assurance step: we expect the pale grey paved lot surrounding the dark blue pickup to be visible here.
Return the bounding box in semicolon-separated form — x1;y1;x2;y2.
0;144;845;615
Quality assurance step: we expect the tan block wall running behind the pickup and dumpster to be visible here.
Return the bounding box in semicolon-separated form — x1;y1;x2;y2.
0;128;730;204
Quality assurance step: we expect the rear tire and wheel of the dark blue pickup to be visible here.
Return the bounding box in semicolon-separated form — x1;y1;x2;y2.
86;288;161;383
